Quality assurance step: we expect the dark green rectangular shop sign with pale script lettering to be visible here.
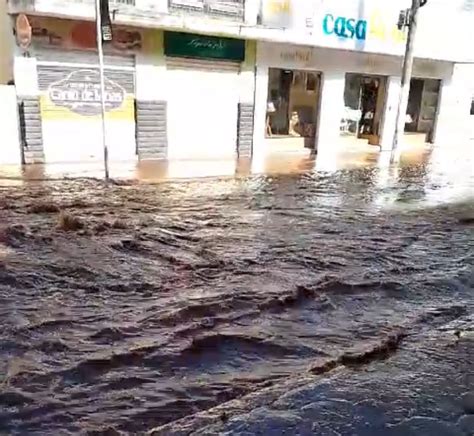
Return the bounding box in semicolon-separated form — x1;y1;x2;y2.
164;32;245;62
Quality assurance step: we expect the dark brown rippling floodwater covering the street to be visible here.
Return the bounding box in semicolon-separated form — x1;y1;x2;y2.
0;158;474;435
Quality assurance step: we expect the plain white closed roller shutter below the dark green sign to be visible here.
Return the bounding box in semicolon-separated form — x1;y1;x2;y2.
166;57;241;159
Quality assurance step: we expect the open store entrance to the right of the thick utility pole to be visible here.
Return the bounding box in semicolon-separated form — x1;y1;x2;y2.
405;79;441;144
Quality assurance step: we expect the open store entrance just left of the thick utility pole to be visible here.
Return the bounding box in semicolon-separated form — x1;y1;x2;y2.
341;73;386;145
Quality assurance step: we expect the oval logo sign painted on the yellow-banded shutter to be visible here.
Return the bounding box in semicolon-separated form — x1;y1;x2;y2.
48;70;126;116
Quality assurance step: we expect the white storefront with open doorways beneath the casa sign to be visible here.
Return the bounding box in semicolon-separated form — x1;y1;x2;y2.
254;42;453;155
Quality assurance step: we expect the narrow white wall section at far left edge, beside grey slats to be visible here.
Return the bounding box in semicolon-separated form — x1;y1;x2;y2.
0;85;21;165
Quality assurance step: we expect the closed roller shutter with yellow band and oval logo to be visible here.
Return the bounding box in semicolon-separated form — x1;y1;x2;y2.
35;48;136;162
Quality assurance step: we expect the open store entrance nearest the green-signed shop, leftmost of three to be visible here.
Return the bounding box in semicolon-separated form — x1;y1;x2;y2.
265;68;320;150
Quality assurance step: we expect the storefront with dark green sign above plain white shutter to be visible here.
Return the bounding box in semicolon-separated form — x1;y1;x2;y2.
163;31;254;160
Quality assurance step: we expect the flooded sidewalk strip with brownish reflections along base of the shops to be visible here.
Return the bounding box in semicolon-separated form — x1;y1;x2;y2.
0;143;452;184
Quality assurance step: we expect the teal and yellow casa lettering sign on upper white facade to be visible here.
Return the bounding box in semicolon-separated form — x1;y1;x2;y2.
322;11;406;43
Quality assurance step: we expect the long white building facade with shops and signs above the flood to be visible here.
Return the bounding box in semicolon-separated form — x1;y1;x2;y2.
3;0;474;163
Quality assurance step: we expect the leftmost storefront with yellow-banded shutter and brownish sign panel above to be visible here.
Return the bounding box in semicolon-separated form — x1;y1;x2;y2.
16;18;142;163
